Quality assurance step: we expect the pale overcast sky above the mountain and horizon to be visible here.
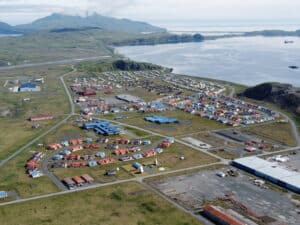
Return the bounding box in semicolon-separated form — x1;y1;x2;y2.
0;0;300;24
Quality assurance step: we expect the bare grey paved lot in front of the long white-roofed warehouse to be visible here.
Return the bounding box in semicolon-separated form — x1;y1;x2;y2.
151;167;300;225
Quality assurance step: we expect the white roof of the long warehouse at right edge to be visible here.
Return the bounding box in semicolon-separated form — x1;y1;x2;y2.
234;156;300;188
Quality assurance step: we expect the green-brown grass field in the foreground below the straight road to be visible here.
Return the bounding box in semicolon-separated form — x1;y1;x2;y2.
0;182;201;225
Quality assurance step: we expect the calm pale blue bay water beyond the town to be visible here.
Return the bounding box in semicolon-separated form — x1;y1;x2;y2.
116;36;300;87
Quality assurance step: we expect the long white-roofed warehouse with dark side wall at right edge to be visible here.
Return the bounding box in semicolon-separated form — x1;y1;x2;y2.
232;156;300;194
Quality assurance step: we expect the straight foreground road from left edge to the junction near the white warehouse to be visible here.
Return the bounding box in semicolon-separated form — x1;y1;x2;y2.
0;162;223;206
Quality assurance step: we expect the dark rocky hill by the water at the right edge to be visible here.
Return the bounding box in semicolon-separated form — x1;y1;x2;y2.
239;83;300;115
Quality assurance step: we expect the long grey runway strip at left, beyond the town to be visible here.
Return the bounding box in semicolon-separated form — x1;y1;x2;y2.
0;55;111;71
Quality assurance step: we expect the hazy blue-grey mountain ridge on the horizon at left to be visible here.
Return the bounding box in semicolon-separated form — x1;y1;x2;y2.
15;13;166;33
